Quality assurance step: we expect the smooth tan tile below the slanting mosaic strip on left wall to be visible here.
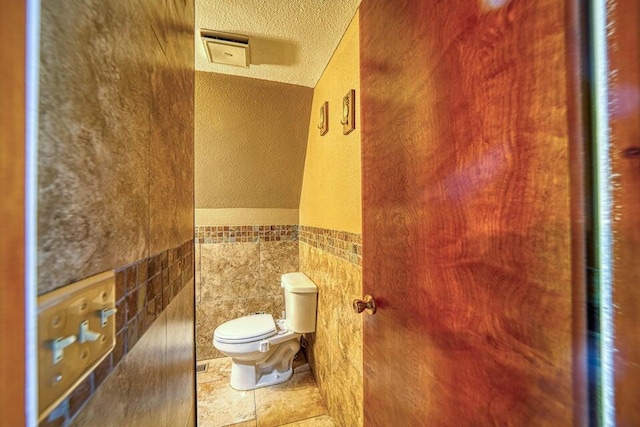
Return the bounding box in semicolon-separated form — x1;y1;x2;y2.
71;270;195;427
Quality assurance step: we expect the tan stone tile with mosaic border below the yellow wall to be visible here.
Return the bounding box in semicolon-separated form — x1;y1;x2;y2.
299;226;363;426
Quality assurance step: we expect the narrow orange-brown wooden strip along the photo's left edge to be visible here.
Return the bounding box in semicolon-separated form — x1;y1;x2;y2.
0;1;26;426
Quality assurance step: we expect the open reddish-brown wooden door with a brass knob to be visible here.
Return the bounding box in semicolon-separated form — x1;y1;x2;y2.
360;0;586;426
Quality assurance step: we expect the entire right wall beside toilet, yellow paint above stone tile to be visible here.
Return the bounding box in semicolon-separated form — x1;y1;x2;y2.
299;10;363;426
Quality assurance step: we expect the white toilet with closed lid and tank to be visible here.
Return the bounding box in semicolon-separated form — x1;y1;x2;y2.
213;273;318;390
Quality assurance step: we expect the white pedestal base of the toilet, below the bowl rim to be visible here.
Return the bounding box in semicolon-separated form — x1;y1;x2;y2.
230;338;300;391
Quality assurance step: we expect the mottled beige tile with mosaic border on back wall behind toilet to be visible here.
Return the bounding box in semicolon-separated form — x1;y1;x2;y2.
195;225;298;360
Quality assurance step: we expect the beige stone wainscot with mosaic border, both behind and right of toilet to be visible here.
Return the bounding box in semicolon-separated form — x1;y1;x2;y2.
195;226;363;426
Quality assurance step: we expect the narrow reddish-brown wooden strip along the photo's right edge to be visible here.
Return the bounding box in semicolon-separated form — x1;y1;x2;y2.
609;0;640;426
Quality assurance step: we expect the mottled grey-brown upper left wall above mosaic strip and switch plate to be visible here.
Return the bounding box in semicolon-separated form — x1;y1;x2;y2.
38;0;194;293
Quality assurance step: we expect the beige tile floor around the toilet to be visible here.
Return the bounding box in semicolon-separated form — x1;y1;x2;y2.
197;354;334;427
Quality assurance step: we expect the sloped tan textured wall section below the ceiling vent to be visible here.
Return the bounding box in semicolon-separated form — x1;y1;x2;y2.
195;72;313;212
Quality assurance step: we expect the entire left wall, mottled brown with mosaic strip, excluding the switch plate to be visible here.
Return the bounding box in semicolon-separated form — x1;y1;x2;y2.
38;0;194;426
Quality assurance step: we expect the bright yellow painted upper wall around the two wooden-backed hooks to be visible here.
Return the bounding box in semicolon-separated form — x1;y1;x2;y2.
300;13;362;233
